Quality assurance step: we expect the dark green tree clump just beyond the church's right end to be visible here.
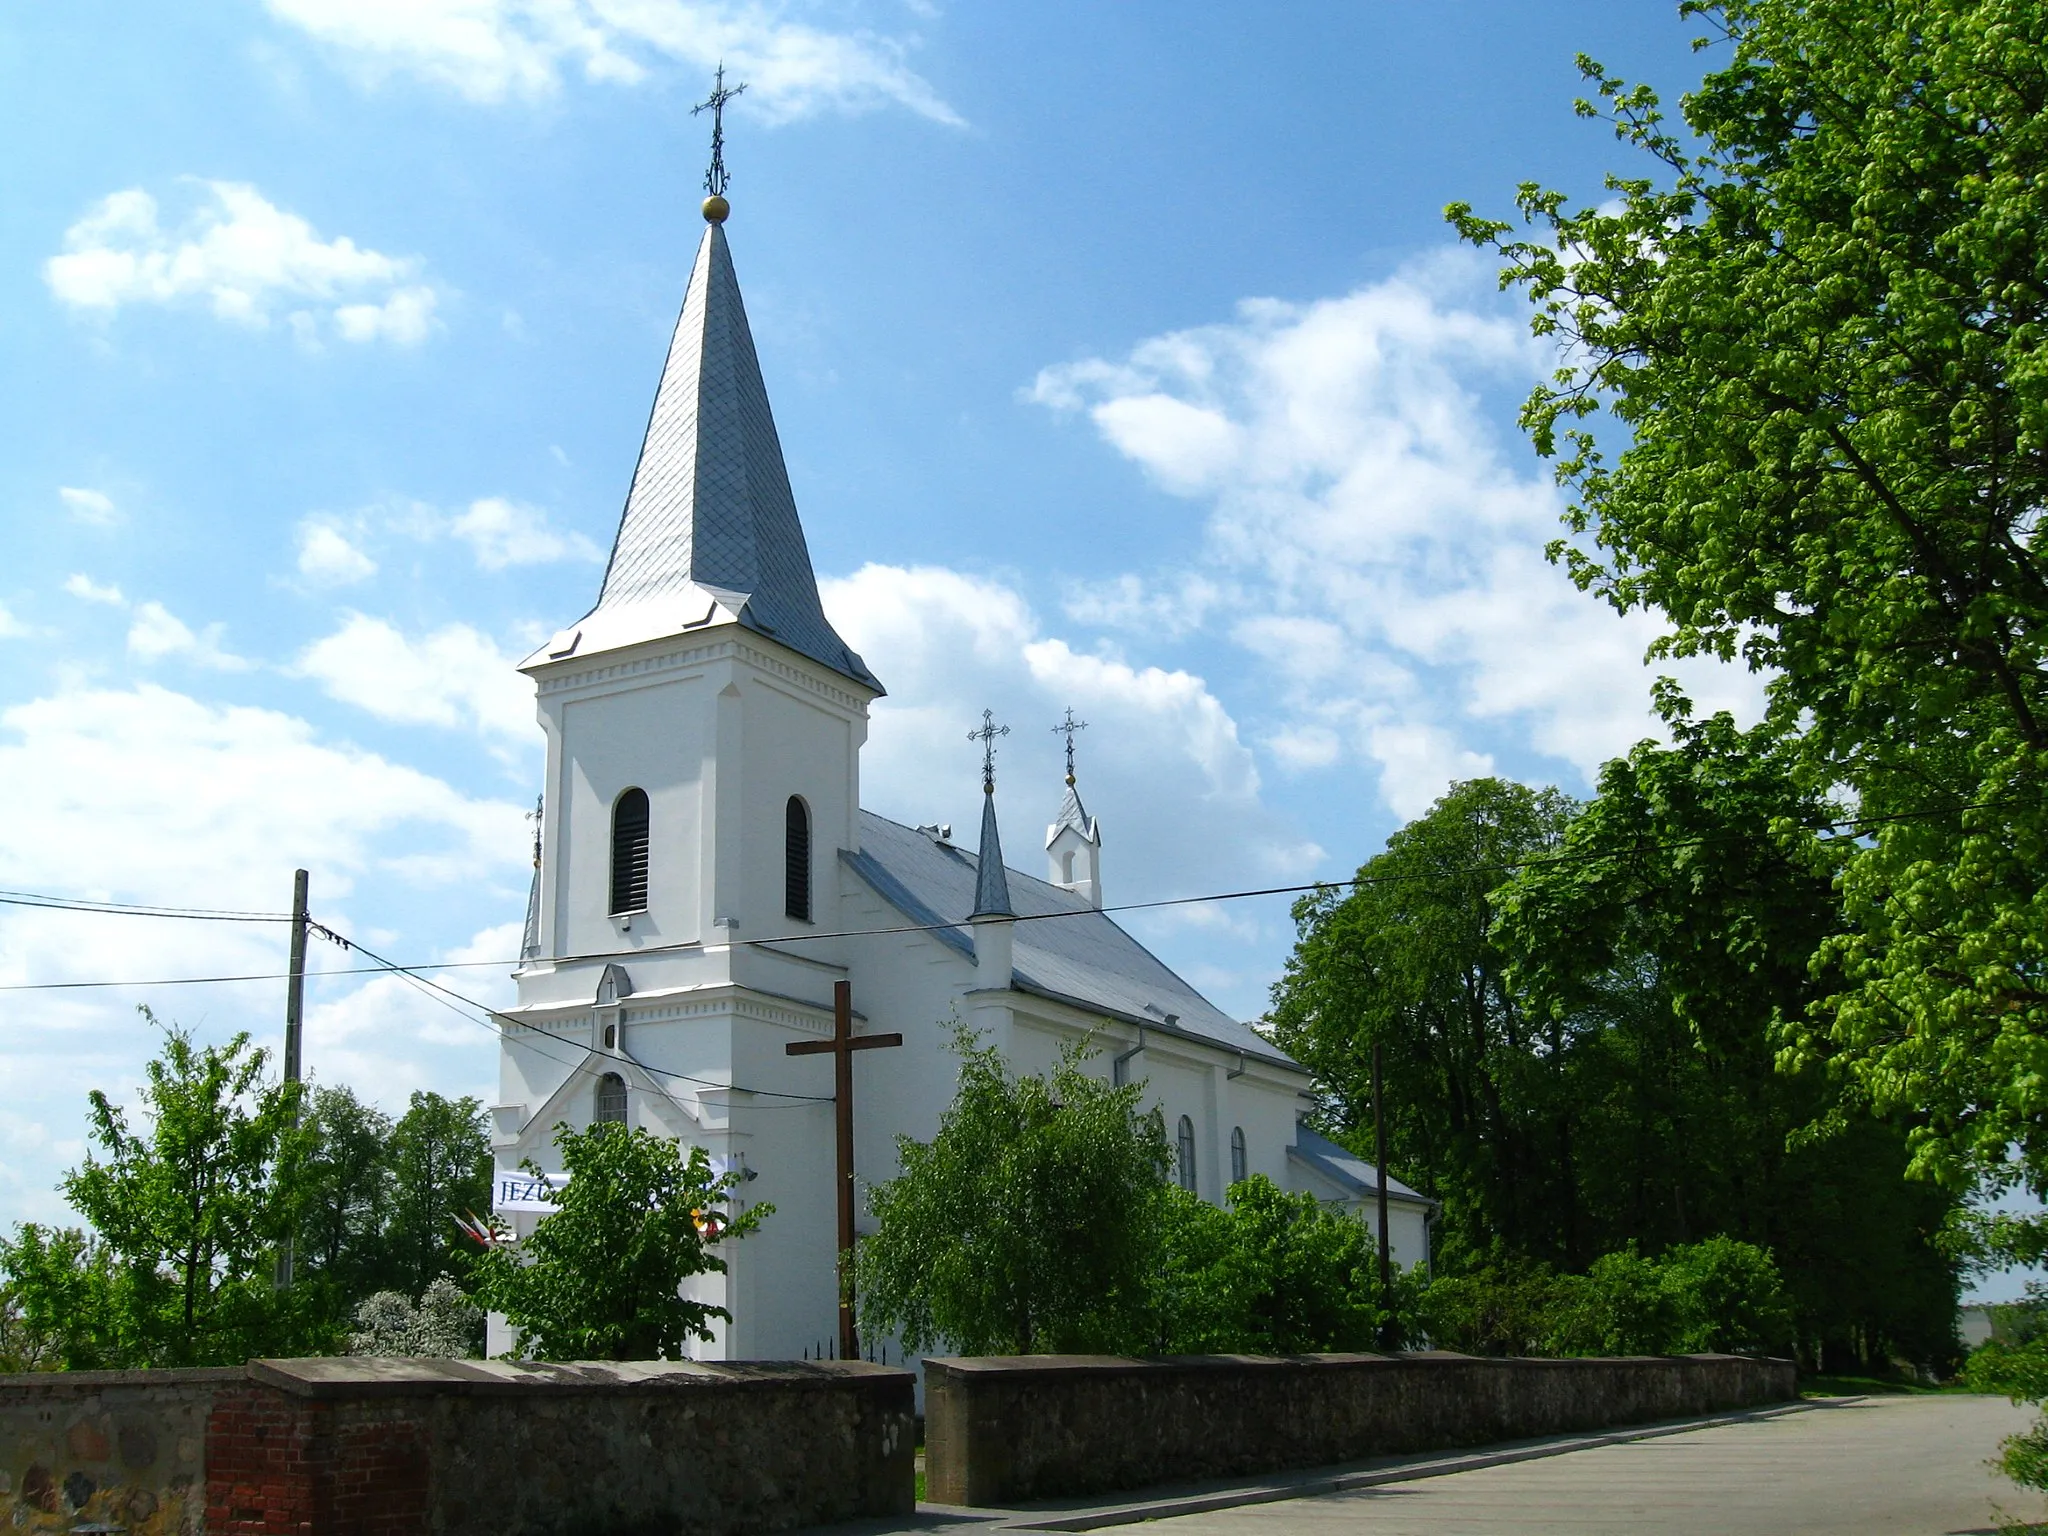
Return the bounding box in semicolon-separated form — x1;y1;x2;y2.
1272;761;1956;1362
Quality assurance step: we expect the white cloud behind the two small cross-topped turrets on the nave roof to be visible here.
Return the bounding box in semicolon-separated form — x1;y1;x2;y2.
819;565;1323;999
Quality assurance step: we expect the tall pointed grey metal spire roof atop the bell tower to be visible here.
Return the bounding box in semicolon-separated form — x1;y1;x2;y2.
563;223;881;690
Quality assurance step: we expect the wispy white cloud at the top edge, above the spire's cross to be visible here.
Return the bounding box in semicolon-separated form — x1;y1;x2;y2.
266;0;961;123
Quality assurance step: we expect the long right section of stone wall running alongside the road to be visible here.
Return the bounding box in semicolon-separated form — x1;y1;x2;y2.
924;1354;1798;1505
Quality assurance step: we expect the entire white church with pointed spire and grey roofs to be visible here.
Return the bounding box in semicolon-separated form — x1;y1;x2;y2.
489;199;1432;1358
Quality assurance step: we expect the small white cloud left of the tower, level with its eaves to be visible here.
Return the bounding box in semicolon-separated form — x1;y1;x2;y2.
293;612;541;743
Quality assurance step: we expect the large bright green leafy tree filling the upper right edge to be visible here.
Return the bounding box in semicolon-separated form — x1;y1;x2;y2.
1450;0;2048;1212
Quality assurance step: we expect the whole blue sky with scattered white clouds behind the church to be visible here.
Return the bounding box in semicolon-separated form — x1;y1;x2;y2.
0;0;1859;1269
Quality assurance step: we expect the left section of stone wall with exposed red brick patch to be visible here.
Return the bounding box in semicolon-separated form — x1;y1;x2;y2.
0;1358;913;1536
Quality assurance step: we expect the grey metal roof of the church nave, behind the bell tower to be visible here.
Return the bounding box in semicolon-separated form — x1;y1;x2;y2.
840;811;1300;1071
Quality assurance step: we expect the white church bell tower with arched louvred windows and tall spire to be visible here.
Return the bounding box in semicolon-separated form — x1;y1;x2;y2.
494;147;883;1356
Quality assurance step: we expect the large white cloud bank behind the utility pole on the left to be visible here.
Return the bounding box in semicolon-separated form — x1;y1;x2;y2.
0;684;526;1221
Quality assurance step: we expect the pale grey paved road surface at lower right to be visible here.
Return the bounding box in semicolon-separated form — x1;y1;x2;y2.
1145;1397;2042;1536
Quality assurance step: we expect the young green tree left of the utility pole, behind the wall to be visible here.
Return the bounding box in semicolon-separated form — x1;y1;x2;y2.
0;1010;319;1366
